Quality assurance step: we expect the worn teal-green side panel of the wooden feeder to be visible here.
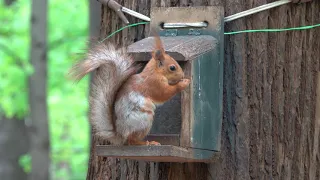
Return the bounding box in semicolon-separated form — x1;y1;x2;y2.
191;46;223;151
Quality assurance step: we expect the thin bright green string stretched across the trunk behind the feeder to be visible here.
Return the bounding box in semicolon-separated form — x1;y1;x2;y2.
100;22;320;43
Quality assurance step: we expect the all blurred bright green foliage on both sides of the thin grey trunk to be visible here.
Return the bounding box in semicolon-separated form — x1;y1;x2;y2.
0;0;89;180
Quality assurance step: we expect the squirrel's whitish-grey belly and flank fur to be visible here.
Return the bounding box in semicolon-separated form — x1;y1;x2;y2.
115;91;156;140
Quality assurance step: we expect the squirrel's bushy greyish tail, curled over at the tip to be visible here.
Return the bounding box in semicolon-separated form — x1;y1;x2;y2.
69;43;138;145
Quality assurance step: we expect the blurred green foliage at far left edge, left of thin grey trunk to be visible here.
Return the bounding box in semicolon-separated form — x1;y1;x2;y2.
0;1;32;118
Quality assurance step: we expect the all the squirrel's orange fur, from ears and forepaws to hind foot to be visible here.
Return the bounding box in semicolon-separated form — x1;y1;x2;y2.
124;36;190;145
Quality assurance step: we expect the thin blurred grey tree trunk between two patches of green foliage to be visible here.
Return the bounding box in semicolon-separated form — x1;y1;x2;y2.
29;0;50;180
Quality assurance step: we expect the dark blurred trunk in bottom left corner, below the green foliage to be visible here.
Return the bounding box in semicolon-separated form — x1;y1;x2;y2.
0;116;29;180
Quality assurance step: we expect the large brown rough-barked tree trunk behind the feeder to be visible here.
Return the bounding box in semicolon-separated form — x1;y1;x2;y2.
87;0;320;180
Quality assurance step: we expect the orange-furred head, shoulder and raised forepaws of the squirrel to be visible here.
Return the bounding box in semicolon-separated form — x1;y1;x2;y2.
135;36;190;103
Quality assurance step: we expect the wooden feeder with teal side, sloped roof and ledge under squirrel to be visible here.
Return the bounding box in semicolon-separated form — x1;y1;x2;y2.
96;6;224;162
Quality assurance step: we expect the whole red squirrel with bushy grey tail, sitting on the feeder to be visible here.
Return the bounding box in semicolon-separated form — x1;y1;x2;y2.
70;36;190;145
